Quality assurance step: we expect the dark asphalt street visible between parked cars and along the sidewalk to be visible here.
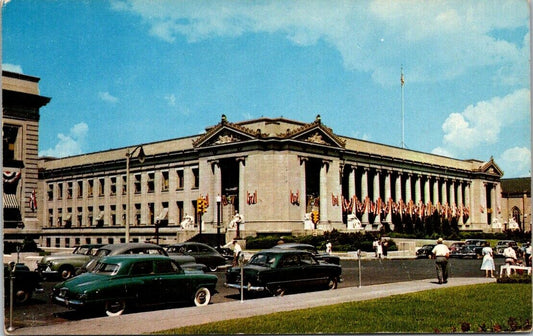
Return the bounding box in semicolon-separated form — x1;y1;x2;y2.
4;259;503;328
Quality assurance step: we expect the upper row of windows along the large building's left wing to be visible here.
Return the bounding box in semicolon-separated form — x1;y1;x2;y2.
47;168;200;201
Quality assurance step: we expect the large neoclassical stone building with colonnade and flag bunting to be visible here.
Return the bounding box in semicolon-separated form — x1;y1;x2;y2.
39;116;503;247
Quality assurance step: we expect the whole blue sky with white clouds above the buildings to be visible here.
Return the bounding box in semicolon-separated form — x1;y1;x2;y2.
2;0;531;178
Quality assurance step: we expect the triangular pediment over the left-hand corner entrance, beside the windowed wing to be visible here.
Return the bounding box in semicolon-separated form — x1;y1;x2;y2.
193;116;260;148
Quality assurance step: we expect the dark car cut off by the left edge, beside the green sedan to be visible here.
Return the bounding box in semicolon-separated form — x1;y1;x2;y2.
4;262;43;304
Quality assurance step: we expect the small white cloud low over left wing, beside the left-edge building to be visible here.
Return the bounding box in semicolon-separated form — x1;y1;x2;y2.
39;122;89;157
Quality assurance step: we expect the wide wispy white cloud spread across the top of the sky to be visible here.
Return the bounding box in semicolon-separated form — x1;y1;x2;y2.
112;0;529;85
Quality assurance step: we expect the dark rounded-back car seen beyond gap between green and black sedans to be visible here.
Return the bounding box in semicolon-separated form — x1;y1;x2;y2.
166;242;226;272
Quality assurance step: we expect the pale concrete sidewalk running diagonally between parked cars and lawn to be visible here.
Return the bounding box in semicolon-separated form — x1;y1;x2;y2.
8;277;494;335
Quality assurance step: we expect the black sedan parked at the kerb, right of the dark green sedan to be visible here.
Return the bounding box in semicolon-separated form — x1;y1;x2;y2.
225;248;342;295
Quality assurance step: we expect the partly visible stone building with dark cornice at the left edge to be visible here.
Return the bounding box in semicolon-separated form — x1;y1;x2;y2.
2;71;50;240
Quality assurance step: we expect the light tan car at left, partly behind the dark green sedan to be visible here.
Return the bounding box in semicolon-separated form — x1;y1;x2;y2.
36;244;102;280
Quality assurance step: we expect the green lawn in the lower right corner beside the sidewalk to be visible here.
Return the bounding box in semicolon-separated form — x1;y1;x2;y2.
153;283;532;334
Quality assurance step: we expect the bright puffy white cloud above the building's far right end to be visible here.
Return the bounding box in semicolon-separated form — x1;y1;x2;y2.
434;89;530;156
